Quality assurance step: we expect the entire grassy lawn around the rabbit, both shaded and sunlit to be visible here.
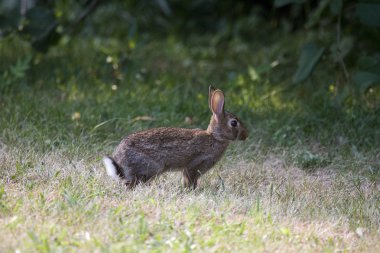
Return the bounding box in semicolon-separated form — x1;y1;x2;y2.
0;21;380;252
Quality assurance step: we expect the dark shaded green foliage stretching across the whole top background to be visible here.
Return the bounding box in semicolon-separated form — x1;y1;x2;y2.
0;0;380;106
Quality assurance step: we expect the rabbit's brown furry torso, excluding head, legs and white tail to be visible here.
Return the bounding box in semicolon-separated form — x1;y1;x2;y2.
113;128;228;176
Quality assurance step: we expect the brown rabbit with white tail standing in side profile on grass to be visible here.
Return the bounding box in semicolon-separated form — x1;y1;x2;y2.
103;86;248;189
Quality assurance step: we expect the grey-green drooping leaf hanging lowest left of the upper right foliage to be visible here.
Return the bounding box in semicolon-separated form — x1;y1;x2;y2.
293;42;324;83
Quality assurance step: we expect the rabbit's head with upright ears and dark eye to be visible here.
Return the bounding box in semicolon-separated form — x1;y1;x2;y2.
207;86;248;141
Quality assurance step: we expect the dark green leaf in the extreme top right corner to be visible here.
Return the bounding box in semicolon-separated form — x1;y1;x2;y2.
355;3;380;27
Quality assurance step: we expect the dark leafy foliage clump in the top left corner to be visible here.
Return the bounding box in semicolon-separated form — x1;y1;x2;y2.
0;0;98;52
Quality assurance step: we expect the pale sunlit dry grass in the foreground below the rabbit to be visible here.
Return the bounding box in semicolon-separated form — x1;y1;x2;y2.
1;150;379;252
